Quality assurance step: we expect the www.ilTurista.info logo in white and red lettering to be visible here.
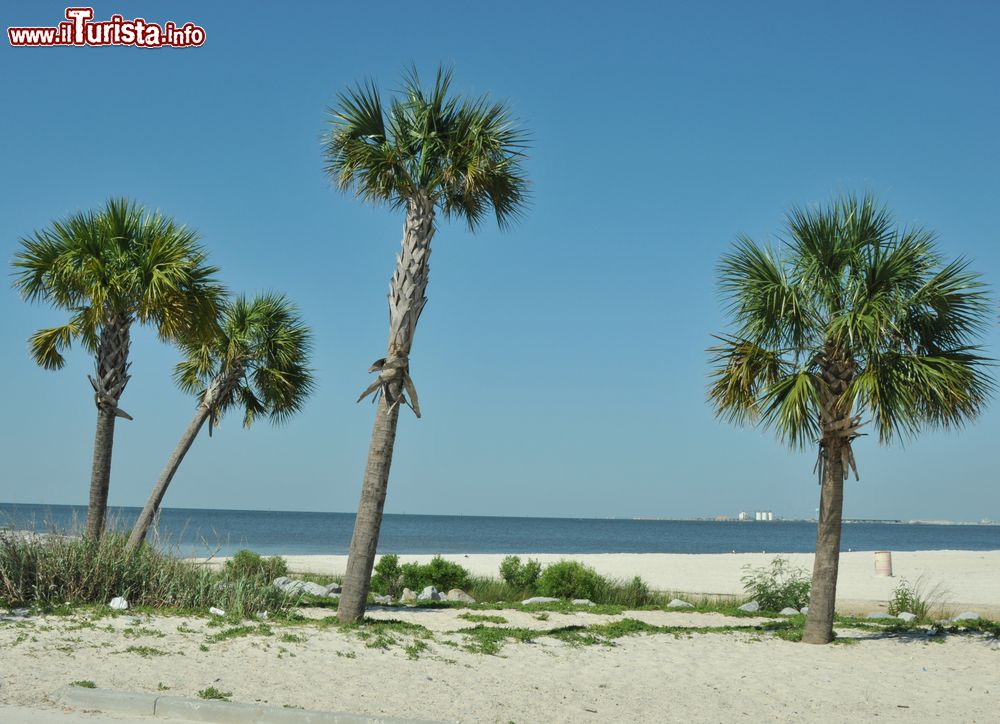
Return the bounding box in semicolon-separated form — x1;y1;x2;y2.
7;8;205;48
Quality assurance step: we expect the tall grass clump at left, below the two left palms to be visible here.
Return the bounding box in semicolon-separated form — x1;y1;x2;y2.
0;532;298;618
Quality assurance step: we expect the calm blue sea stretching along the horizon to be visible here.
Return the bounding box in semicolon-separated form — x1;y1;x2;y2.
0;503;1000;555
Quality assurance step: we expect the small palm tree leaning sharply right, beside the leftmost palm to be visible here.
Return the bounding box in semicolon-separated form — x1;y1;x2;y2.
128;294;313;549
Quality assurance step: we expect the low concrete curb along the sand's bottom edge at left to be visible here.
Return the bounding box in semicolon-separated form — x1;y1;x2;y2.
49;685;446;724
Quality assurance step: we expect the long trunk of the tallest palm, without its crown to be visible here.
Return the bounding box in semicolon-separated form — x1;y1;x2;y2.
337;193;434;623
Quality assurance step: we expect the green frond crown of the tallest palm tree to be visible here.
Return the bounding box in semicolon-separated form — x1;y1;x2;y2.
324;69;527;228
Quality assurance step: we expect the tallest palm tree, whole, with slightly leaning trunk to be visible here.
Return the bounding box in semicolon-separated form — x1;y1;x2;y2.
324;69;527;621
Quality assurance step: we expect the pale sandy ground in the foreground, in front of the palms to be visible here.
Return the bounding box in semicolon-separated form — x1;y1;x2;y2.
0;609;1000;723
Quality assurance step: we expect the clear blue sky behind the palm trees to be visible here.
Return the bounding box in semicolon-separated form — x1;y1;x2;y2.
0;1;1000;519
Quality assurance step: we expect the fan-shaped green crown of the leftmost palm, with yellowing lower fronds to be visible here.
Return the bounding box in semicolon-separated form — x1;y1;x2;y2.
13;199;223;369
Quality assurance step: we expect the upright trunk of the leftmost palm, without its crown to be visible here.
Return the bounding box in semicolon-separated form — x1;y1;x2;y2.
87;314;132;540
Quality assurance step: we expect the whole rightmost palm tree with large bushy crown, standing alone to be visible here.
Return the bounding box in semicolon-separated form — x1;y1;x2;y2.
709;196;993;644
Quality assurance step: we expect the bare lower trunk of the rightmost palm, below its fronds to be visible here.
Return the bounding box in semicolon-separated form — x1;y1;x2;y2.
802;443;845;644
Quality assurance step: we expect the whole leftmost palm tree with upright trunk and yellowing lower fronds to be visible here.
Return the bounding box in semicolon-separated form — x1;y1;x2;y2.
13;199;224;539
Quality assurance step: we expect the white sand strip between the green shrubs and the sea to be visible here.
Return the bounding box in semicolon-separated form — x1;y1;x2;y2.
266;548;1000;618
